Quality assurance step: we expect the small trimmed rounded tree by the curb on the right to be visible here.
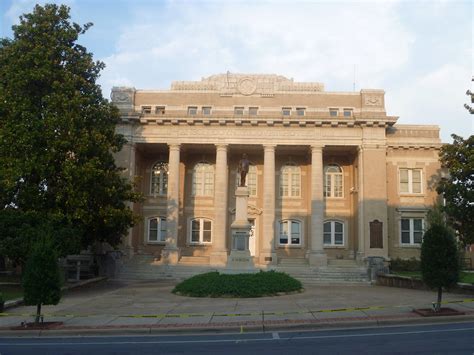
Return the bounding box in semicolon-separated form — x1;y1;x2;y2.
421;224;460;311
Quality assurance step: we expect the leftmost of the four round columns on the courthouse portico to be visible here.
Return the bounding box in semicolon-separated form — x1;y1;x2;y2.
162;144;180;264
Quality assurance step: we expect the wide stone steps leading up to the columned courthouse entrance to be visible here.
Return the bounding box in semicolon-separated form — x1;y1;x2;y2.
118;255;369;285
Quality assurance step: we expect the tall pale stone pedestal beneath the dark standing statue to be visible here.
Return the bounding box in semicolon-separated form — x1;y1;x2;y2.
227;186;254;270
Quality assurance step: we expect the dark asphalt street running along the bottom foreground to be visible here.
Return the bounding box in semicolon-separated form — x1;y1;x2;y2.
0;322;474;355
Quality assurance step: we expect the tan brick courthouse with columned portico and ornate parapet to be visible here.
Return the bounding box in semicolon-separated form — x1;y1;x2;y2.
112;73;441;268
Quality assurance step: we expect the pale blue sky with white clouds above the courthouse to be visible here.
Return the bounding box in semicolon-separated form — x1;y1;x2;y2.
0;0;474;142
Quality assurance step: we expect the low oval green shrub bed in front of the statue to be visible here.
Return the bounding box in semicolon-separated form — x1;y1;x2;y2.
172;271;303;297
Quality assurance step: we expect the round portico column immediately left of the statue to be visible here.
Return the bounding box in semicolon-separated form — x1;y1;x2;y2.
210;144;229;265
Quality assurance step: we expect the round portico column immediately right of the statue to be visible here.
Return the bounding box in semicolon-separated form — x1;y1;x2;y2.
260;145;277;264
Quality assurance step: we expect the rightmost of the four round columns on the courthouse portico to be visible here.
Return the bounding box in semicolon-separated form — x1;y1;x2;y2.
308;145;327;266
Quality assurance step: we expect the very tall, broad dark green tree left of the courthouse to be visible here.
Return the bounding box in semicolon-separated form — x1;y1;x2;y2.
0;4;139;253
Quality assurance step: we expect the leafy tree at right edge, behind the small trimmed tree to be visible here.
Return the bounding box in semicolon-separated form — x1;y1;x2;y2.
437;134;474;245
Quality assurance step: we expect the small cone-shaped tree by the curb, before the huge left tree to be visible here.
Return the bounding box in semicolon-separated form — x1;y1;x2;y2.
22;235;61;323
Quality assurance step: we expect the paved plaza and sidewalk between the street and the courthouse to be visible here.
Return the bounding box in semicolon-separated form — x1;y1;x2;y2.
0;280;474;336
